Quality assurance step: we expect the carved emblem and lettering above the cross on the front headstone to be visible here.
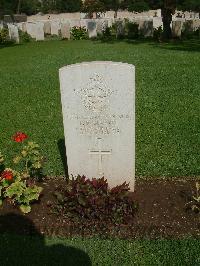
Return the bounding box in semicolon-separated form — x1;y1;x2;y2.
68;73;133;136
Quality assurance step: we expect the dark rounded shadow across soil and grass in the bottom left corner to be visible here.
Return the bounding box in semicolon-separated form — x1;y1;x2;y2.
0;213;92;266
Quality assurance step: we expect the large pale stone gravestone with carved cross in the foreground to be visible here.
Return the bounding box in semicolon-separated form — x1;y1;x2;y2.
59;62;135;190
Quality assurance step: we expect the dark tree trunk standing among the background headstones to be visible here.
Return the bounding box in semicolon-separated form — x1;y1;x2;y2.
161;7;172;39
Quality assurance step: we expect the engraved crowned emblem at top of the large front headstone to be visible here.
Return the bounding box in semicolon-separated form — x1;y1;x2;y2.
75;73;113;112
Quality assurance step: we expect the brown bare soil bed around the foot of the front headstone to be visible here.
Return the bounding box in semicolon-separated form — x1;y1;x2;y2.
0;178;200;238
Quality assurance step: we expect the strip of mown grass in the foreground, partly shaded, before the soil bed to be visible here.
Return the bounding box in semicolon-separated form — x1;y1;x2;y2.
0;234;200;266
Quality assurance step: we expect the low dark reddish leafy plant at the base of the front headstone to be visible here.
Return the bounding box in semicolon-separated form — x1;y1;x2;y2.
53;176;136;227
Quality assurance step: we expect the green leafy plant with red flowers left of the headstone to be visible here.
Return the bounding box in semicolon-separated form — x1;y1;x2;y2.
0;132;42;213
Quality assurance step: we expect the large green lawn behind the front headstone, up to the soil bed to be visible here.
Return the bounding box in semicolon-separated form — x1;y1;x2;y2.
0;41;200;177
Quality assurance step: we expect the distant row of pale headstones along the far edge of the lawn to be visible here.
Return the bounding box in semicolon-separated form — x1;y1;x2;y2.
0;18;200;43
